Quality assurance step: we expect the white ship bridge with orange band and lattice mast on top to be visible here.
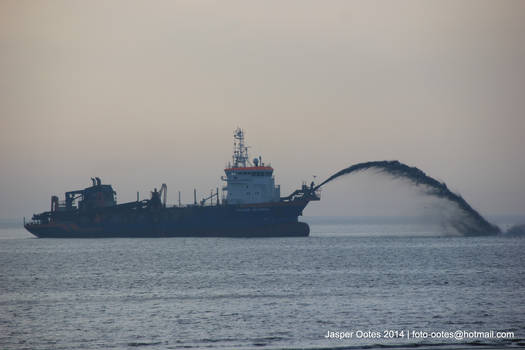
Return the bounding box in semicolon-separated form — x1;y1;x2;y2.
222;128;281;204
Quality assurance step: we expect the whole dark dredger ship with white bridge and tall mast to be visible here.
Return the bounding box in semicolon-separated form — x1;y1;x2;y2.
24;128;320;238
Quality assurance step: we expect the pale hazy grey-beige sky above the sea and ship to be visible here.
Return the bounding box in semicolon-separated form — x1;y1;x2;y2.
0;0;525;219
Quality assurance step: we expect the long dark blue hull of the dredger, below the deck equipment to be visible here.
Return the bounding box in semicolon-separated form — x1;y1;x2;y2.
25;201;310;238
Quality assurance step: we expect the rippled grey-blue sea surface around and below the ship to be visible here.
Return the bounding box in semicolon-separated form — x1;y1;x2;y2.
0;219;525;349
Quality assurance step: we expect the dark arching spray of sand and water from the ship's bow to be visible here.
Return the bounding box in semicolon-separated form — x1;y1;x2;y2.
315;160;501;236
